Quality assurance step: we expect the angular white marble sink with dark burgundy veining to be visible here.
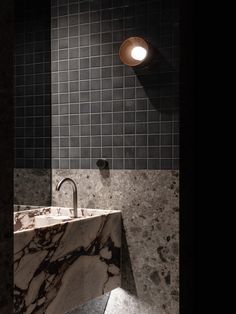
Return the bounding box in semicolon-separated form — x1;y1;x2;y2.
14;207;121;314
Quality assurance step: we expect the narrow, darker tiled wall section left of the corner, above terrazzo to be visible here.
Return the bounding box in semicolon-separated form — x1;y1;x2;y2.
15;0;51;168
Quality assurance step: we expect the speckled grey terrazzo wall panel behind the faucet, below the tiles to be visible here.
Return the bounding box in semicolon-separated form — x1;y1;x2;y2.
52;170;179;314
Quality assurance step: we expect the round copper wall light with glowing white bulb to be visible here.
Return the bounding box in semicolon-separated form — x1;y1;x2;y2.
119;37;150;67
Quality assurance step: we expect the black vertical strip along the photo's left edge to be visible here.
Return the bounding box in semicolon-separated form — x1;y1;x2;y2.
0;0;14;314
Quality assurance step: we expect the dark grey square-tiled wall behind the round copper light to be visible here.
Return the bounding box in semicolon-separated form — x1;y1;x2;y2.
51;0;179;169
